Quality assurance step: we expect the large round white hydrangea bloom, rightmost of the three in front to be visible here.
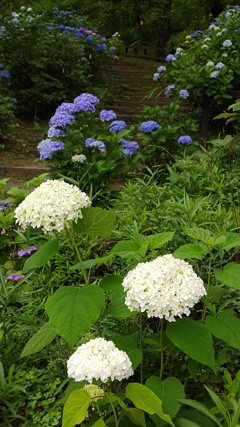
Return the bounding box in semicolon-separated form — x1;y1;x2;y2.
123;254;206;322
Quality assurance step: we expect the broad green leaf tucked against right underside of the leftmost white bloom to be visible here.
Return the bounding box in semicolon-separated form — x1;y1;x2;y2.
74;207;115;237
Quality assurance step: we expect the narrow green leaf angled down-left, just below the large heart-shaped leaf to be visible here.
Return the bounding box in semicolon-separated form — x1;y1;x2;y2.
20;322;57;357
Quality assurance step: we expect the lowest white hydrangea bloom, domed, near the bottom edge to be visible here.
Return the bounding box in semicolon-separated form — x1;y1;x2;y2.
67;338;133;383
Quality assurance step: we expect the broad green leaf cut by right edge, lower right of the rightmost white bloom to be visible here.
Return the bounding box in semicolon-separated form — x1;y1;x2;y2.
205;310;240;350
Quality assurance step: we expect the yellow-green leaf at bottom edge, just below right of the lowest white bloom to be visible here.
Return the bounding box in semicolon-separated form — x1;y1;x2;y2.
126;383;174;427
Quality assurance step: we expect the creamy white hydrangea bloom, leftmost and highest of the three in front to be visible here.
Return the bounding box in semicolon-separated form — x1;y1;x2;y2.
15;180;91;233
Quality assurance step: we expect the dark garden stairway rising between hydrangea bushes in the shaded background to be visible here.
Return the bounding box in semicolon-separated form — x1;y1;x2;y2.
100;56;170;122
